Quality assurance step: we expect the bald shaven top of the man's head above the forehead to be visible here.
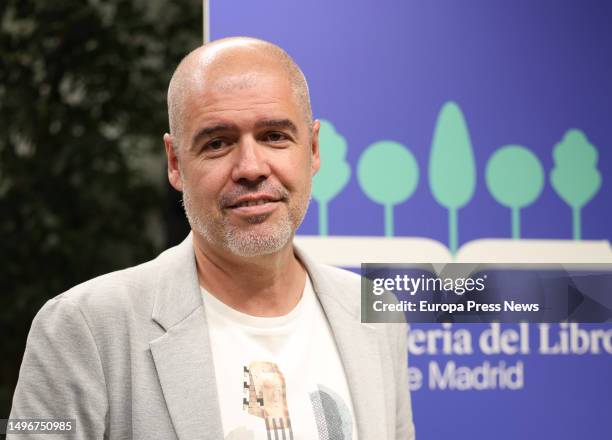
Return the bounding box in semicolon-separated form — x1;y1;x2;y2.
168;37;312;147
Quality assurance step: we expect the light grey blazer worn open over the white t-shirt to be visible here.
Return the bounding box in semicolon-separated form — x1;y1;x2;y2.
8;235;414;440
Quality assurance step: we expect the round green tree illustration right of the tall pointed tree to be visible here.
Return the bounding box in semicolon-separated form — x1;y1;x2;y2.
486;145;544;239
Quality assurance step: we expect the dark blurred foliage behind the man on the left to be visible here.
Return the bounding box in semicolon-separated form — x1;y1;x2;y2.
0;0;201;417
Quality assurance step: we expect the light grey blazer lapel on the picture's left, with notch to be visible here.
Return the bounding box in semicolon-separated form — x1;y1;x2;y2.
150;234;223;440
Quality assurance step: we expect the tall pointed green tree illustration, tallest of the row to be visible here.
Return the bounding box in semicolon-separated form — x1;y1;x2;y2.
429;102;476;254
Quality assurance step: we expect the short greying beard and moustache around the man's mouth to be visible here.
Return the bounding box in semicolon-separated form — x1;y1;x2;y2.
183;180;310;257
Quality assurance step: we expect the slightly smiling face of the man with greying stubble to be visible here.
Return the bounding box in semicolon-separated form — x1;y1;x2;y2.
170;70;319;257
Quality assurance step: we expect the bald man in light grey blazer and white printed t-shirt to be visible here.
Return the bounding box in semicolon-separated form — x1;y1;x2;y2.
9;38;414;440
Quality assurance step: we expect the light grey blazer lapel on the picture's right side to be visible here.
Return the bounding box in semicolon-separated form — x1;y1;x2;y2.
296;249;387;440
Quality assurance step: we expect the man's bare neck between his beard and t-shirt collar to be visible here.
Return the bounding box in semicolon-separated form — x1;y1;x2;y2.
193;232;306;317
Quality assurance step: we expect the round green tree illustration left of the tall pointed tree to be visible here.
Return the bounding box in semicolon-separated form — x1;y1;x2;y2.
357;141;419;237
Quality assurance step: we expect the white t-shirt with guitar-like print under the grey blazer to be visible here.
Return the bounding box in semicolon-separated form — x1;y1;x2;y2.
202;279;357;440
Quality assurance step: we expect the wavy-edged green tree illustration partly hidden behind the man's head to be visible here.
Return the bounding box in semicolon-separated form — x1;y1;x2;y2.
312;119;351;235
